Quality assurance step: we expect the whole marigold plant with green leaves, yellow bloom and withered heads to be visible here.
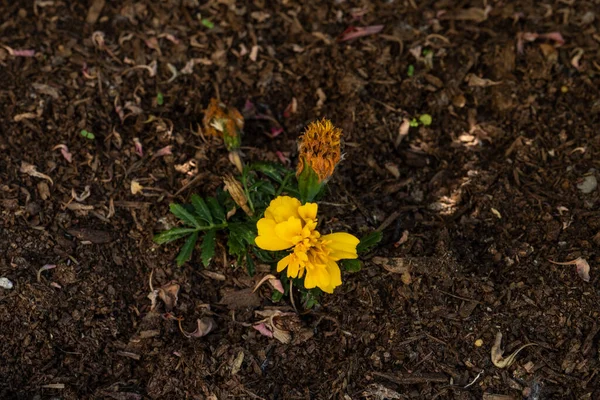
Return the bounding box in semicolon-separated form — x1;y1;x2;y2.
154;111;381;308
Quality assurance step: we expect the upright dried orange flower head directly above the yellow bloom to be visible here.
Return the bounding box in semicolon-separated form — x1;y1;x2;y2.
296;118;342;182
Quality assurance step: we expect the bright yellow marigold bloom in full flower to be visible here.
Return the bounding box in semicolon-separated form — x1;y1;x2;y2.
255;196;359;293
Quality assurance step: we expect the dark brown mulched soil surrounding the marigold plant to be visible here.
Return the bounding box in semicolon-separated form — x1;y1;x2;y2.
0;0;600;400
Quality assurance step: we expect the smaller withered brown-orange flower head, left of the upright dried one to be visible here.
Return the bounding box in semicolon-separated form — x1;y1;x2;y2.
203;98;244;150
